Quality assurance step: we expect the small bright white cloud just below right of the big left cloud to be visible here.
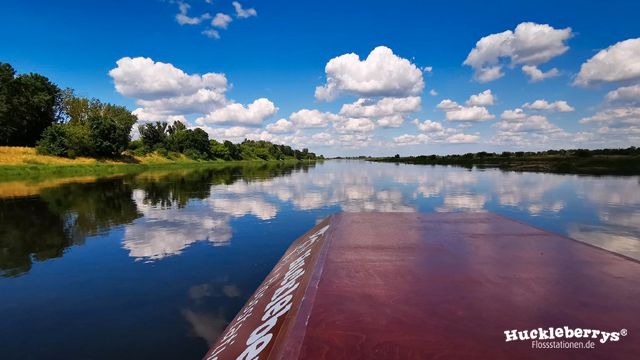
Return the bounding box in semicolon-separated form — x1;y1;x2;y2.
196;98;278;126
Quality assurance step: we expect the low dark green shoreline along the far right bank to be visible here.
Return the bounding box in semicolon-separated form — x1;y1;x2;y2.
368;147;640;175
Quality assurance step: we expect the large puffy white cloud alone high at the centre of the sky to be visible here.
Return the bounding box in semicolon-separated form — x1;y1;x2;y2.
315;46;424;101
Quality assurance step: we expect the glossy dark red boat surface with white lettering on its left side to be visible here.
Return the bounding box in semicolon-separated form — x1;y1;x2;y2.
205;213;640;360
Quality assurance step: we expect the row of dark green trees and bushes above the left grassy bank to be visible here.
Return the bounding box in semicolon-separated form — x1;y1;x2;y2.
0;63;322;160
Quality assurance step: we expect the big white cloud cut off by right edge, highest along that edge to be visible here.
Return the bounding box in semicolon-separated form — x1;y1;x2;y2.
574;38;640;86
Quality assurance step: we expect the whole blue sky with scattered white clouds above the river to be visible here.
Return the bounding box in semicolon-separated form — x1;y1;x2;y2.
0;0;640;155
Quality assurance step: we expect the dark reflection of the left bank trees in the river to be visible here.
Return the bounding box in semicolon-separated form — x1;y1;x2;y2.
0;163;315;277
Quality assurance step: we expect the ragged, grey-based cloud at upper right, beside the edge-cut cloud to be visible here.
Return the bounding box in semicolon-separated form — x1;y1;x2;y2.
464;22;573;82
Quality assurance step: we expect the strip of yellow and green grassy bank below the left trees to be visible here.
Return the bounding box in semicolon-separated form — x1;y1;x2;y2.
0;147;320;182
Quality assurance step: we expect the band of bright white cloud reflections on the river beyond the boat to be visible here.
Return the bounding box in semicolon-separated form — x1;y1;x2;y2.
124;161;640;260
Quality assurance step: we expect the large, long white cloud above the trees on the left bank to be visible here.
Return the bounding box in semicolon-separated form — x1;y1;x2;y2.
109;57;227;100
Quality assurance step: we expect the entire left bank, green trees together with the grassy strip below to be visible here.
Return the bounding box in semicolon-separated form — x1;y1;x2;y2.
0;62;324;181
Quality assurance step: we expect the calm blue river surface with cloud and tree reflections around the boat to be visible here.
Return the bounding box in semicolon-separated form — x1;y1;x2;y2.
0;161;640;359
